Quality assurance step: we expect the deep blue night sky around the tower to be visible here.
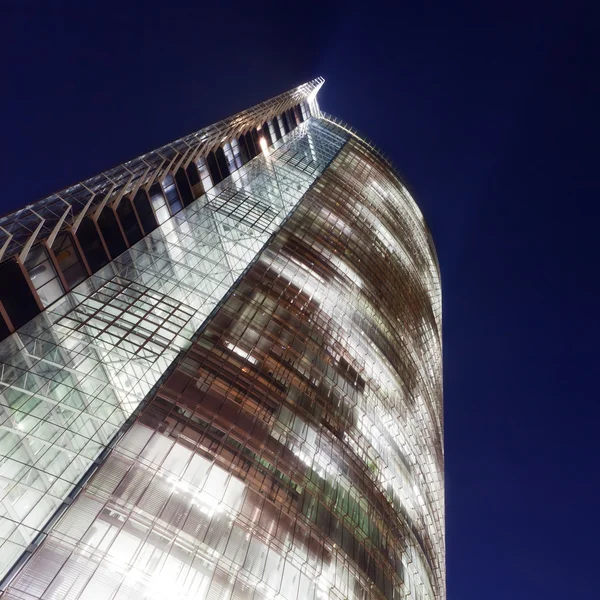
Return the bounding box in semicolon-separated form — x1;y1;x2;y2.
0;0;600;600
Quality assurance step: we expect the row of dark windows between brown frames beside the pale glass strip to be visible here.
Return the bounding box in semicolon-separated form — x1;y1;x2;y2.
0;98;318;350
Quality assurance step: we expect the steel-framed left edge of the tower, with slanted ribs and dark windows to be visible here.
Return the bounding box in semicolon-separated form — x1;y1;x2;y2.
0;78;323;339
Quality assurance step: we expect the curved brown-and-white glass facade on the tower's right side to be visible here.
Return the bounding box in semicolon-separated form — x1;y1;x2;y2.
2;124;445;600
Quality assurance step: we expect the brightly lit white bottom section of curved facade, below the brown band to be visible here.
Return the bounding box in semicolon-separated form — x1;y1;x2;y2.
4;420;369;600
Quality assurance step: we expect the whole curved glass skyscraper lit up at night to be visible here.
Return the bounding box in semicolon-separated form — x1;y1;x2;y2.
0;79;445;600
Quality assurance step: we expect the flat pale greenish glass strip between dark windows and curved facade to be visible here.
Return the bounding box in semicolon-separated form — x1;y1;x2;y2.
0;120;345;574
